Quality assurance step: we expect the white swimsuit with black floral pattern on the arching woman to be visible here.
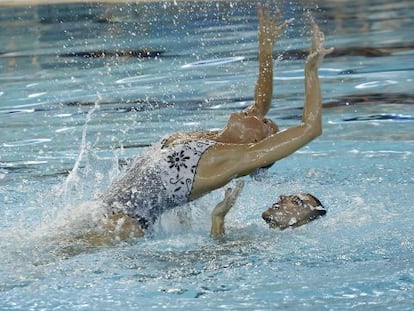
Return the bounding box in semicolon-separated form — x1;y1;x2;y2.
103;140;216;229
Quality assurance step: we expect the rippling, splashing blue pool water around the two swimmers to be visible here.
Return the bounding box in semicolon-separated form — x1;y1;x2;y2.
0;0;414;310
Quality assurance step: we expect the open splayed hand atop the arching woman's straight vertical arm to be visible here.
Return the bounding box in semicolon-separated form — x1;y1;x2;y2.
257;3;293;53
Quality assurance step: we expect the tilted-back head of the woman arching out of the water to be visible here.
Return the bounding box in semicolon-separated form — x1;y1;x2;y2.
225;112;278;143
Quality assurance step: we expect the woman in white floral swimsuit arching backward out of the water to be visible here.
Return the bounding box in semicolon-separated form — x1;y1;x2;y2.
98;4;332;237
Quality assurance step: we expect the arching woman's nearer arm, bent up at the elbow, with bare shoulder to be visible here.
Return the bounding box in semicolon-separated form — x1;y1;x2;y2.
190;20;332;199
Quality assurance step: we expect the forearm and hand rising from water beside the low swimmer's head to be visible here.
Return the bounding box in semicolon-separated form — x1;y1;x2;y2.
210;180;244;237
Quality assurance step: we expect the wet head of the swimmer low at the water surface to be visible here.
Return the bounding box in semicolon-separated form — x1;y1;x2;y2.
262;193;326;230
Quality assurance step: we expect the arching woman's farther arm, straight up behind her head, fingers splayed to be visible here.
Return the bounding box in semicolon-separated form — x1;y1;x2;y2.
246;4;292;117
